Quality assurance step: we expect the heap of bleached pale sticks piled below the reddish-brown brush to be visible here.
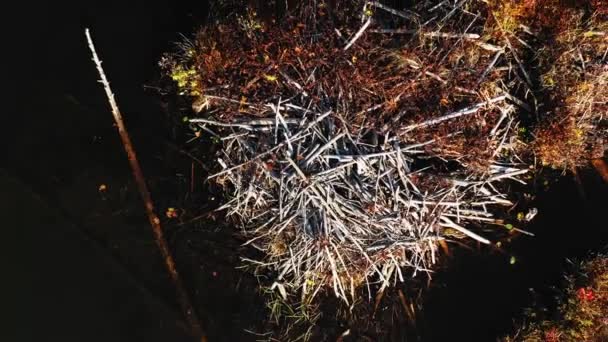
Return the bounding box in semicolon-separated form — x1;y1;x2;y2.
190;101;527;301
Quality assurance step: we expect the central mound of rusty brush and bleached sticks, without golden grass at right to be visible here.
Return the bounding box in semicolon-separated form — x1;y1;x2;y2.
163;0;605;302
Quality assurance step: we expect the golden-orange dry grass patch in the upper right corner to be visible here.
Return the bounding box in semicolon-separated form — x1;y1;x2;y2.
486;0;608;170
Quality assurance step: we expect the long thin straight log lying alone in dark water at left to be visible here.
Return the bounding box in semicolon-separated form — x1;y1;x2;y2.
85;29;207;341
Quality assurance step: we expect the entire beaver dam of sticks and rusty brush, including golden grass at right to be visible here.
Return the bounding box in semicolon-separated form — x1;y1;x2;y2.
64;0;608;341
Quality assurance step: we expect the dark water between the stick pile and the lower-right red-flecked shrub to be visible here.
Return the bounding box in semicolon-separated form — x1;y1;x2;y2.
425;172;608;341
